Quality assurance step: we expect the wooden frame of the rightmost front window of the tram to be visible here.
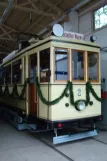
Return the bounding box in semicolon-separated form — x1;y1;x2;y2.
87;51;100;83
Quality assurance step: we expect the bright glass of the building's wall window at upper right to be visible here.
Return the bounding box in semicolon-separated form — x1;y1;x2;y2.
94;5;107;30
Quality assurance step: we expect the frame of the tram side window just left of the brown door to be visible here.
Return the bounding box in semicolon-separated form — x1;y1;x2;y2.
11;58;23;85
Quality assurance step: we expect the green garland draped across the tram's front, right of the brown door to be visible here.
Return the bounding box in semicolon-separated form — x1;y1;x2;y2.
35;77;102;107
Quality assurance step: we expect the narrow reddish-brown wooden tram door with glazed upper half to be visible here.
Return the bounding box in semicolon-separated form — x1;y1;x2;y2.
29;54;37;116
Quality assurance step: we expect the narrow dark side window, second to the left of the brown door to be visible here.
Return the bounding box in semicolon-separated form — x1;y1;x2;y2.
5;65;11;84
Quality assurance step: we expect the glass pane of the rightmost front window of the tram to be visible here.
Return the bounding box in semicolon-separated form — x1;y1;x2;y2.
88;52;98;81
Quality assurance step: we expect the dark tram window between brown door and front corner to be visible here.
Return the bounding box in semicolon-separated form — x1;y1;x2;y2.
39;48;50;82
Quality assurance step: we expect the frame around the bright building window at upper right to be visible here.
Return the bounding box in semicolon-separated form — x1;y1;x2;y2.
92;3;107;32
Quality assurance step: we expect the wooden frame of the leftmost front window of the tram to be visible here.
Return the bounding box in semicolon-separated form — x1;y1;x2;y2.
53;47;70;83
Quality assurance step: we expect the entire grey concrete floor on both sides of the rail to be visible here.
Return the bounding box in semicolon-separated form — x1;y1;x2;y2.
0;122;107;161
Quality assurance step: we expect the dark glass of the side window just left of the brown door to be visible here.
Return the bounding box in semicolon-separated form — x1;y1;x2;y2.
12;59;22;83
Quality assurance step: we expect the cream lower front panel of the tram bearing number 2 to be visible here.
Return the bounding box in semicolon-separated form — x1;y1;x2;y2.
50;85;101;121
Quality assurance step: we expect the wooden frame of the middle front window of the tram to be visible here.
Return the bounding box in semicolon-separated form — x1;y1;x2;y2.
71;49;87;83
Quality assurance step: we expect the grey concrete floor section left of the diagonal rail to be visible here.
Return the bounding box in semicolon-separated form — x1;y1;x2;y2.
0;122;67;161
